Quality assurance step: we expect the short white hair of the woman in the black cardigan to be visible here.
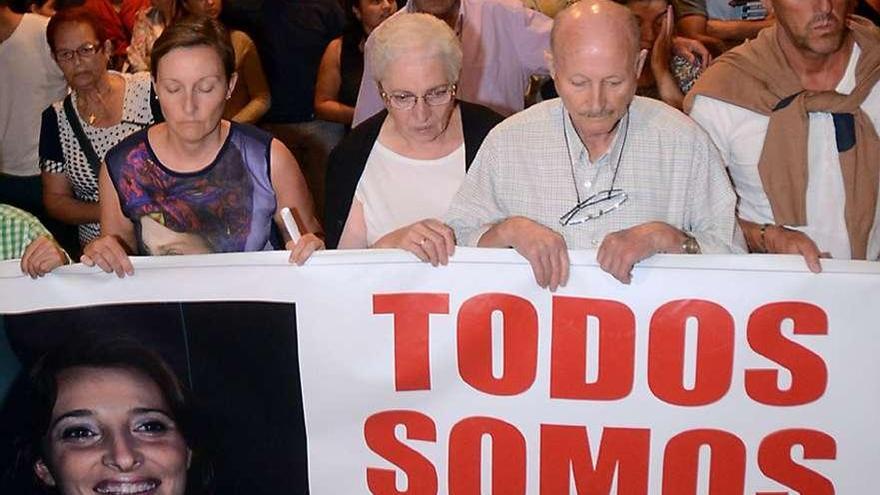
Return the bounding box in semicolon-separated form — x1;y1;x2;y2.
365;12;462;83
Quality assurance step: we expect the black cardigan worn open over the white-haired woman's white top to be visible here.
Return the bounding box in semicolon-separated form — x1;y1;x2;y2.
324;101;504;249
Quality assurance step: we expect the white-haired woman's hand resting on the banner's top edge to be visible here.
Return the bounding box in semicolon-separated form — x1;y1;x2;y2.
372;218;455;266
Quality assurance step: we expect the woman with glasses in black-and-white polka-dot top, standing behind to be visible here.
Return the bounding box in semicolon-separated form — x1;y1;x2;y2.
40;7;159;256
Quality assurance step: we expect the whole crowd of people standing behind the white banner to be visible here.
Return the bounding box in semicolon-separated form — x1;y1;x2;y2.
0;0;880;290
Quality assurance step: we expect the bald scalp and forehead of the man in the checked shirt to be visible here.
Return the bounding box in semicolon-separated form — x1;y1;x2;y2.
550;0;641;60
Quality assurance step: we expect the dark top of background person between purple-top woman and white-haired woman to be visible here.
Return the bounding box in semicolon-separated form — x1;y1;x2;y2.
257;0;345;123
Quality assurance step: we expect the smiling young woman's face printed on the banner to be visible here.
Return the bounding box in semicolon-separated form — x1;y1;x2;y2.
35;367;190;495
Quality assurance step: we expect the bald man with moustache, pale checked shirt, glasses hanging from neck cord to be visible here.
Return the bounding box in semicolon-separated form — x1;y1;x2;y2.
446;0;745;290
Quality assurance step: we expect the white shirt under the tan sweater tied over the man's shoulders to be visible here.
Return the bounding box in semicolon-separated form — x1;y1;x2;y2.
691;45;880;260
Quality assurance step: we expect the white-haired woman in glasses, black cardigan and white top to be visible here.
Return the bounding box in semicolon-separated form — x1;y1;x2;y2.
325;13;501;265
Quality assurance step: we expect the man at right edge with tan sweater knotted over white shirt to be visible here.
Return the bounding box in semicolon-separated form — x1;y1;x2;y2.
685;0;880;272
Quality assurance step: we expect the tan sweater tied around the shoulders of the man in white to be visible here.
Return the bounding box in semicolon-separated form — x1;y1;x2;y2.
684;16;880;259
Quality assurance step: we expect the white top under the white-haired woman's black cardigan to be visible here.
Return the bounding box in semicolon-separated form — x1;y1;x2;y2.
354;139;465;246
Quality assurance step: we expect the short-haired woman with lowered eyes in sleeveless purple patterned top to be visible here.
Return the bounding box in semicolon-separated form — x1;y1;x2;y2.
82;17;324;277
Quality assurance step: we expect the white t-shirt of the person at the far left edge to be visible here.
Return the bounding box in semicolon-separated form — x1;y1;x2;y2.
0;14;67;176
